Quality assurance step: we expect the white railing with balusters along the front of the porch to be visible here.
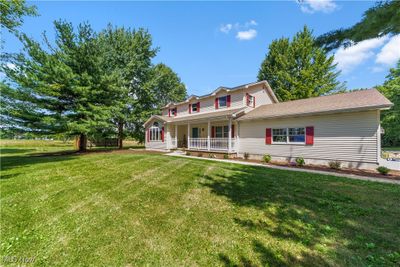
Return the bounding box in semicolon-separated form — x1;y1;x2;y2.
188;138;236;152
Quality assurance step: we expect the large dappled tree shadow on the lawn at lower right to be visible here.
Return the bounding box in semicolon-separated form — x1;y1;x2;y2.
203;166;400;266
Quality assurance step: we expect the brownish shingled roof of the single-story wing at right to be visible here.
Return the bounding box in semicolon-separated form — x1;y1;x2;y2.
237;89;393;121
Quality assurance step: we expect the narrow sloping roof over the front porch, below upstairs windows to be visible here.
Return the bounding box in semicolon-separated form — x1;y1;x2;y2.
162;107;246;123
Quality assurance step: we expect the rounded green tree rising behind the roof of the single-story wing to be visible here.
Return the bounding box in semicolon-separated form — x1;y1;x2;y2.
258;26;344;101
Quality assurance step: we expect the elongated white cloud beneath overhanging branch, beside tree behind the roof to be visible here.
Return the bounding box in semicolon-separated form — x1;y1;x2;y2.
335;37;387;73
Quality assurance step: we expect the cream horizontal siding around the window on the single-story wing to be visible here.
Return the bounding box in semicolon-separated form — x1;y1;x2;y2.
239;111;379;163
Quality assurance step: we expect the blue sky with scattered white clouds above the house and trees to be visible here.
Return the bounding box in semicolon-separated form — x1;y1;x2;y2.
3;0;400;95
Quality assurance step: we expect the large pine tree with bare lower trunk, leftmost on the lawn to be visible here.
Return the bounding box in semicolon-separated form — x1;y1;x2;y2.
1;21;118;151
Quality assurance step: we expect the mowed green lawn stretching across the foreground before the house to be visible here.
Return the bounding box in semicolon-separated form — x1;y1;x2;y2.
0;144;400;266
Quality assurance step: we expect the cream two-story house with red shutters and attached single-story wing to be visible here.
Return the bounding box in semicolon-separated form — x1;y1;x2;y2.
144;81;392;171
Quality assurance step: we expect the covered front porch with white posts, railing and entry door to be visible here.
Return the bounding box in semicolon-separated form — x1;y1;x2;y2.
166;118;238;153
